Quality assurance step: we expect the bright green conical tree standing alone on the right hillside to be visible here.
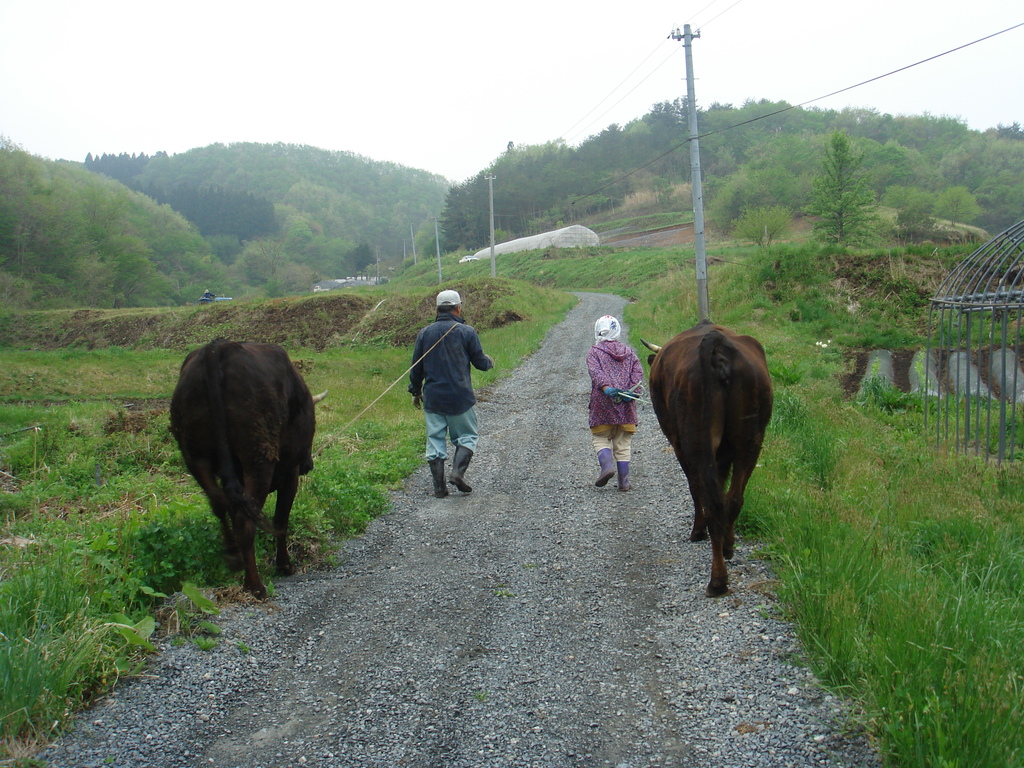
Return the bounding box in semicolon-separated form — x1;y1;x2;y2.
809;131;877;245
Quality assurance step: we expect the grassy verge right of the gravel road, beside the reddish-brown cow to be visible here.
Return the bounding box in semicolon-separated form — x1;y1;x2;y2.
628;241;1024;768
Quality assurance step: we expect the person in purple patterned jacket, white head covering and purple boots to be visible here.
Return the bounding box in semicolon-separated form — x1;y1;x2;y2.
587;314;643;490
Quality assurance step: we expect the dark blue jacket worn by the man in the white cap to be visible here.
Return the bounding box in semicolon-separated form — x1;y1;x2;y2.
409;312;495;416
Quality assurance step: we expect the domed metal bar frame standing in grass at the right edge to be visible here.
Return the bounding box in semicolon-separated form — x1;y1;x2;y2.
916;221;1024;463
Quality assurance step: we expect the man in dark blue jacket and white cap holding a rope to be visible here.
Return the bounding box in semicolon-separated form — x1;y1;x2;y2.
409;291;495;498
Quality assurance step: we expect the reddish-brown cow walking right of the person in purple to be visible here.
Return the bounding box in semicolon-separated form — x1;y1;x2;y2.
641;321;772;597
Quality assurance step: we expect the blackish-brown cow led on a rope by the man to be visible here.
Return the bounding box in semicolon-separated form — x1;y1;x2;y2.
171;339;327;598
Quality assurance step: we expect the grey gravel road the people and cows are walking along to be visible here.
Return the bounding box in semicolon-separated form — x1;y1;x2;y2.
38;294;880;768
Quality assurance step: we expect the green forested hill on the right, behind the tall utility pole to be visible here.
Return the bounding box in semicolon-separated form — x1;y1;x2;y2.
441;99;1024;250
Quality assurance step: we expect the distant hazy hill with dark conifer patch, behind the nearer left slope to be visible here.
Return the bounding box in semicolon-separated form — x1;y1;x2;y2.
85;143;449;266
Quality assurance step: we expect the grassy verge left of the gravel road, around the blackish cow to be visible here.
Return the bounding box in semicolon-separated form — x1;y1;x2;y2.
0;281;574;758
